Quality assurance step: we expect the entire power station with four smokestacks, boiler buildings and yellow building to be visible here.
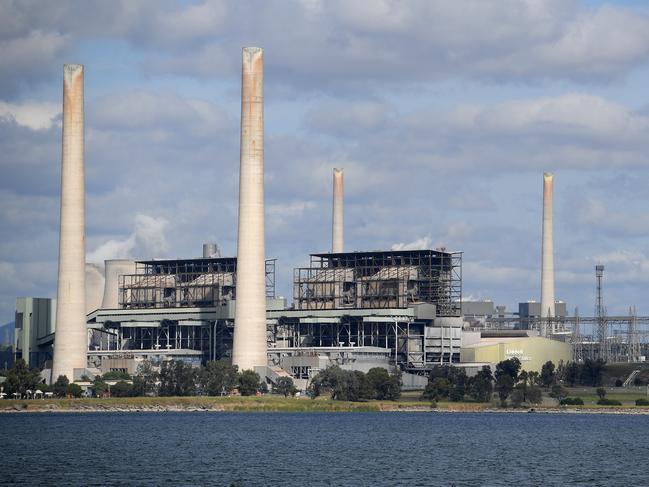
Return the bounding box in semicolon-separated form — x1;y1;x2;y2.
17;47;649;388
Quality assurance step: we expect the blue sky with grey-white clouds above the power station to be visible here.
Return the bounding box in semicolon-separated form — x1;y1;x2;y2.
0;0;649;323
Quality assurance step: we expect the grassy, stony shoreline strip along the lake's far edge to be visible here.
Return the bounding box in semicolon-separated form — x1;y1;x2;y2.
0;396;649;415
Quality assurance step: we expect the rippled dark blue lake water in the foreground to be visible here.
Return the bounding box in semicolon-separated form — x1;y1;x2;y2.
0;412;649;486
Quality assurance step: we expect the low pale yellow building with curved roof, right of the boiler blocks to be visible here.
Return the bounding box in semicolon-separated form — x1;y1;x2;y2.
460;336;572;372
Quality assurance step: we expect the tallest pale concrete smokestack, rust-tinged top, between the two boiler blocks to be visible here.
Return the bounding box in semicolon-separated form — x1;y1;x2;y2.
232;47;267;370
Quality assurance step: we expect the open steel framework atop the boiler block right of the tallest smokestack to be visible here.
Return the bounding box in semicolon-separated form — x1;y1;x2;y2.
293;250;462;316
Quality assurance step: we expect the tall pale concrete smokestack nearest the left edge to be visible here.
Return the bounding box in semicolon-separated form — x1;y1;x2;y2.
52;64;88;381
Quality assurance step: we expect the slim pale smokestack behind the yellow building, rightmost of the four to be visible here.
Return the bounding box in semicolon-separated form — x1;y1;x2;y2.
541;172;554;331
